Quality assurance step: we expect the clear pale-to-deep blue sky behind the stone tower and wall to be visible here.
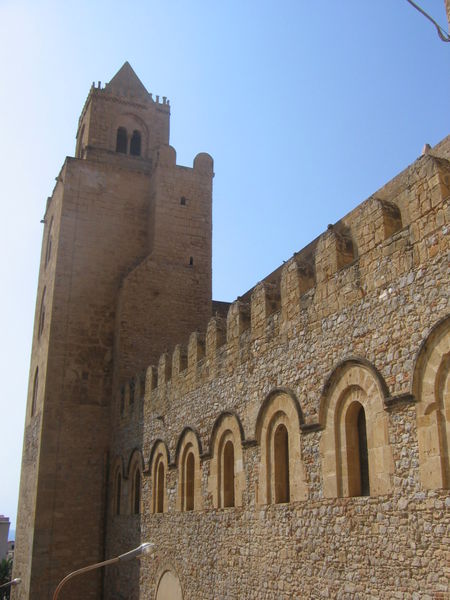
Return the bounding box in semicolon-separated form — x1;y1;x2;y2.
0;0;450;523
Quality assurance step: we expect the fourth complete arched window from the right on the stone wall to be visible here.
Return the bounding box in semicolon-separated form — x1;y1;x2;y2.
177;430;201;511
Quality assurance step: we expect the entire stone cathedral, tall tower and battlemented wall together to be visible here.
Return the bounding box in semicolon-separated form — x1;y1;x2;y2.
12;54;450;600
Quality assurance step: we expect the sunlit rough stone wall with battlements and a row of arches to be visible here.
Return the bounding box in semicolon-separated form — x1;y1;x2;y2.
109;148;450;599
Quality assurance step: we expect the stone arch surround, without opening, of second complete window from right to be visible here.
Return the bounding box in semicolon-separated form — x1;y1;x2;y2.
256;390;308;505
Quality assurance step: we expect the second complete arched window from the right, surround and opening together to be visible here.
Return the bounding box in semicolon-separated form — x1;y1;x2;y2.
256;390;308;504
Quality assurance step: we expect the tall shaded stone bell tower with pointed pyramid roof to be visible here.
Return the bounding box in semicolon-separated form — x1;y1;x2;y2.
13;63;213;600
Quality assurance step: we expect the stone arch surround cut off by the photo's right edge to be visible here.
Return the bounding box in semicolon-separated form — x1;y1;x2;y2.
413;317;450;489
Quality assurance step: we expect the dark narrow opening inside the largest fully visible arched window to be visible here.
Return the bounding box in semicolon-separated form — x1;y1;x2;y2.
345;402;370;496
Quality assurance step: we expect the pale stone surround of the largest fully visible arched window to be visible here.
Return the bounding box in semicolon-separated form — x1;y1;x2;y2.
320;361;394;498
